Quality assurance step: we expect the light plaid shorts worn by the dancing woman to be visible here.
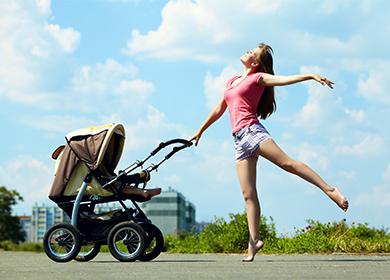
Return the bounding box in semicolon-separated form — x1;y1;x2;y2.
233;123;271;160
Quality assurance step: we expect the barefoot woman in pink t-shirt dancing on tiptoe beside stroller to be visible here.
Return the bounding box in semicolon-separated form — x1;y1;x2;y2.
190;43;348;262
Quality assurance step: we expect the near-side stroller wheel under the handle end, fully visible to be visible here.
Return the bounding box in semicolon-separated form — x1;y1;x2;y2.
107;222;146;262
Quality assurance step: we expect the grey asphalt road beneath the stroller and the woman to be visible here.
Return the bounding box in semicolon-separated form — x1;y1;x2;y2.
0;251;390;280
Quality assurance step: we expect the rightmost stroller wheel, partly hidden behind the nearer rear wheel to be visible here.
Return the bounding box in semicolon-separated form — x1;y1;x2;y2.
138;223;164;262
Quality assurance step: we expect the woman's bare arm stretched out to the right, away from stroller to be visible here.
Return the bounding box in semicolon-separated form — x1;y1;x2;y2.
259;73;334;88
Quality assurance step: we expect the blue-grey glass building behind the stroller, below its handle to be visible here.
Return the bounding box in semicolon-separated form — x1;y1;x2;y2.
141;187;195;235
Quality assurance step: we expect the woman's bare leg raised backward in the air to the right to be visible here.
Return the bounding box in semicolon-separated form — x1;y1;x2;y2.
256;139;348;211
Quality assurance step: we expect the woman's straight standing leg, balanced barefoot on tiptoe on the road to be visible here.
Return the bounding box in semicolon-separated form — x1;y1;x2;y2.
236;157;263;261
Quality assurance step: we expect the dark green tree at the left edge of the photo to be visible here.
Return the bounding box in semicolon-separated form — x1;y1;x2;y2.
0;186;25;243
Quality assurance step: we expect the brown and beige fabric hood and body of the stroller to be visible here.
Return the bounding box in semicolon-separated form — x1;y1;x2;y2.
49;124;125;202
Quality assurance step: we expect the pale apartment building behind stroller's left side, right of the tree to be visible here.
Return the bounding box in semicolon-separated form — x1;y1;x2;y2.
30;204;70;242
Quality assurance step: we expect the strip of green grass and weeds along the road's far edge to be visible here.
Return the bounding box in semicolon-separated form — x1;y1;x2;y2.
0;213;390;254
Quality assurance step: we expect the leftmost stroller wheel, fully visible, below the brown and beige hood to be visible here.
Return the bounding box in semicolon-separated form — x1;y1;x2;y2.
43;223;81;262
